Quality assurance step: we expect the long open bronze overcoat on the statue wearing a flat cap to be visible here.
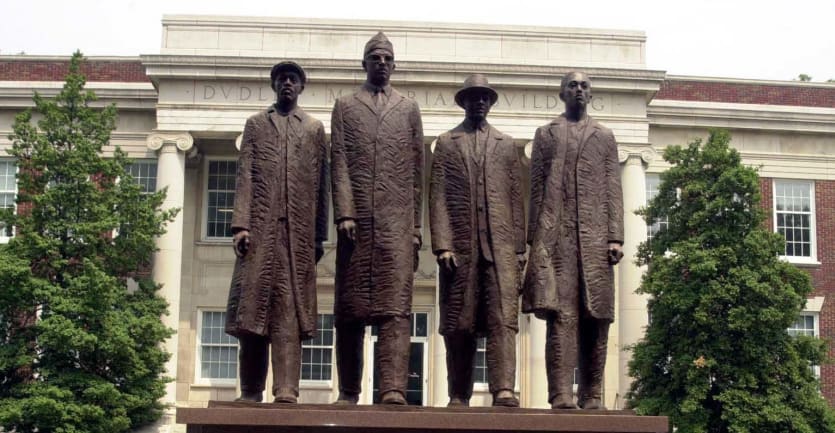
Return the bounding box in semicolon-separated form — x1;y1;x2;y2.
226;107;329;339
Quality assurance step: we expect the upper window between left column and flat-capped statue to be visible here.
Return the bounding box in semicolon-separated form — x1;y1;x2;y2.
206;160;238;239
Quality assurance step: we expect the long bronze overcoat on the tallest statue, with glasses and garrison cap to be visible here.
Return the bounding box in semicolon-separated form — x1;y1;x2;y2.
331;89;424;323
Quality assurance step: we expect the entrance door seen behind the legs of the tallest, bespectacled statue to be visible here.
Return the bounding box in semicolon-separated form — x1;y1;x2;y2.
368;313;429;406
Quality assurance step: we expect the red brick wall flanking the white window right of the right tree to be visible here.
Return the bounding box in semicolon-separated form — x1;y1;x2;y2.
760;178;835;406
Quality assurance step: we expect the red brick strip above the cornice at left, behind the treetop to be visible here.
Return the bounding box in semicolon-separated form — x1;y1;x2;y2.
0;58;150;83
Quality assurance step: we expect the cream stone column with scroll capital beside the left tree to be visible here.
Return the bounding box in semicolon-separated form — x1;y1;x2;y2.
147;132;194;432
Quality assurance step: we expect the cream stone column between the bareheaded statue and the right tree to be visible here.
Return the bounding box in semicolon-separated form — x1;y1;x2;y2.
606;145;655;408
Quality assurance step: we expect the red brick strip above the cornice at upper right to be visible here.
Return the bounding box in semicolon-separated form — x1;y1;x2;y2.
655;79;835;108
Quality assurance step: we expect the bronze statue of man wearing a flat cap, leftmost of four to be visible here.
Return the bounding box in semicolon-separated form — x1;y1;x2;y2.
226;61;329;403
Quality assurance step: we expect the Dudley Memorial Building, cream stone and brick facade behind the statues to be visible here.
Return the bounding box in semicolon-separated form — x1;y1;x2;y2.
0;16;835;426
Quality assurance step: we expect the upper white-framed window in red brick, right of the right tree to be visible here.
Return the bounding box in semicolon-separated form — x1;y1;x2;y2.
774;180;817;262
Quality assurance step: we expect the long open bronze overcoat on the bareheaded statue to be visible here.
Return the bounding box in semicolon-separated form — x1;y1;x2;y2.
522;116;623;320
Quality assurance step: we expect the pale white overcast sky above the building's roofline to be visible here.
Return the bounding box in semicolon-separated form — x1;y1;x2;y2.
0;0;835;81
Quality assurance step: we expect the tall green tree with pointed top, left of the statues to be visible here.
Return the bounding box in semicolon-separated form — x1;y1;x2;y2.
0;52;176;433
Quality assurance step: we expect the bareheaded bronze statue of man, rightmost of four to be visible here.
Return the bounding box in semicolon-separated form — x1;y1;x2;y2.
522;72;623;409
